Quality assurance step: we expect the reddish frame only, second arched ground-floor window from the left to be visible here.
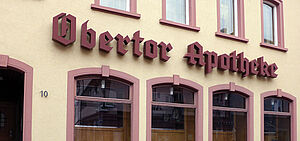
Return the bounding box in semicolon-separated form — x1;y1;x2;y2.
146;75;203;141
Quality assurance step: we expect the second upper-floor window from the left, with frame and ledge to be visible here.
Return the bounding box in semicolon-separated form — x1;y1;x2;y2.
160;0;200;31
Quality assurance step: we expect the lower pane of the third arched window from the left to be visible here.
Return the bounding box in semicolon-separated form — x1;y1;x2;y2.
213;110;247;141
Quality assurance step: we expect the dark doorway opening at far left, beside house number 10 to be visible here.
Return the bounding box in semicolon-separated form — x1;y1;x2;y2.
0;69;24;141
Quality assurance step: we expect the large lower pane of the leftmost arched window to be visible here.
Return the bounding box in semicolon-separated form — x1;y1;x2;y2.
74;101;130;141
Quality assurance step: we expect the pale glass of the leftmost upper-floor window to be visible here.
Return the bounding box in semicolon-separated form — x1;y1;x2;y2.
100;0;128;11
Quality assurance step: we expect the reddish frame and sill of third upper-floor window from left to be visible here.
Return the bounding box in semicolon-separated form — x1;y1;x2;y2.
215;0;249;43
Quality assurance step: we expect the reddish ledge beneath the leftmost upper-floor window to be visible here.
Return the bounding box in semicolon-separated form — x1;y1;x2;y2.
91;4;141;19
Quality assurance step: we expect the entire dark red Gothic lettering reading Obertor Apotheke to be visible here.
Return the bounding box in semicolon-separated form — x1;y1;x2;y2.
52;13;278;78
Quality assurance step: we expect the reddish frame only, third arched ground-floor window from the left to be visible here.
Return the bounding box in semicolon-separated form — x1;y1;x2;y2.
208;82;254;141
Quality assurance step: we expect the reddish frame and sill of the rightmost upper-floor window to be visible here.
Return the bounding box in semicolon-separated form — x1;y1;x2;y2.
260;0;288;52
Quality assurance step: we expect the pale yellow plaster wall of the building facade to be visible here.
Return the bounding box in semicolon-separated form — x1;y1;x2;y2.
0;0;300;141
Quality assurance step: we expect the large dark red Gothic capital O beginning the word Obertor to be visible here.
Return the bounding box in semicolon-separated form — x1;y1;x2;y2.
52;13;76;46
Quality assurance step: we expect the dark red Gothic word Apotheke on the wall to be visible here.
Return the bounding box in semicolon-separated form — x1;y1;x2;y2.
184;42;278;78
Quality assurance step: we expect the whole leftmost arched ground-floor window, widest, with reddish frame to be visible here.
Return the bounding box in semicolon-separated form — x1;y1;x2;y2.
67;66;138;141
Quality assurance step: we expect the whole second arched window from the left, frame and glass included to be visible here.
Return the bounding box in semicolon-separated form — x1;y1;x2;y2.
147;75;202;141
